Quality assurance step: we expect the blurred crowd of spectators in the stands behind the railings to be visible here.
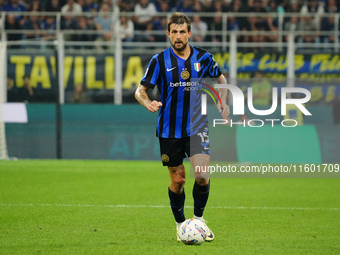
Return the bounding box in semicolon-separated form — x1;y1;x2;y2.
0;0;340;48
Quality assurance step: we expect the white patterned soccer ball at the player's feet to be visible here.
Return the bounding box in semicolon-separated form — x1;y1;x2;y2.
178;219;207;244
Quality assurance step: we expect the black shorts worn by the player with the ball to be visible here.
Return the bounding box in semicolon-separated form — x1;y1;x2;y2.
159;132;210;166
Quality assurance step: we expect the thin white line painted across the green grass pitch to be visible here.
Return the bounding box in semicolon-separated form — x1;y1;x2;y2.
0;203;340;211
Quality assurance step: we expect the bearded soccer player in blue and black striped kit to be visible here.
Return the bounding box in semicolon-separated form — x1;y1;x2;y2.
135;13;229;241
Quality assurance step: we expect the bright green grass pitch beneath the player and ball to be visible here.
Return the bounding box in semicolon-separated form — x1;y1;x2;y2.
0;160;340;254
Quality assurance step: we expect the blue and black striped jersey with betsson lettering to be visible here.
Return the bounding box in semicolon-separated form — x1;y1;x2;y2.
141;46;221;138
